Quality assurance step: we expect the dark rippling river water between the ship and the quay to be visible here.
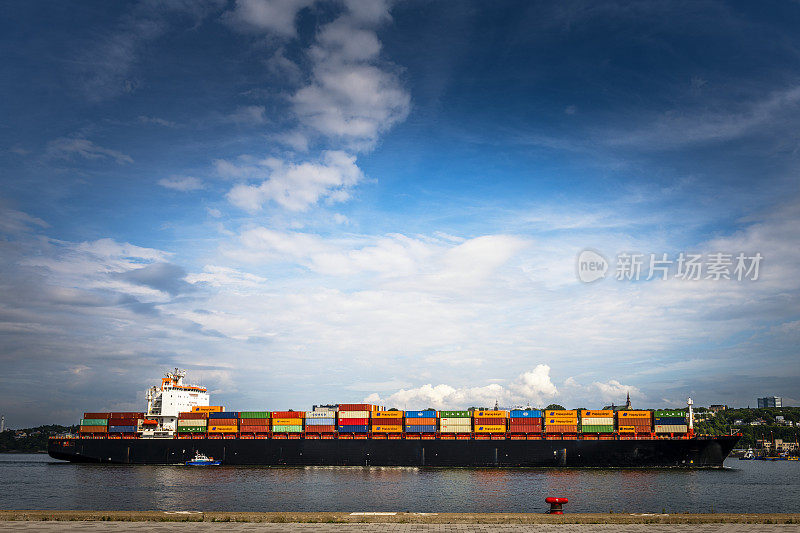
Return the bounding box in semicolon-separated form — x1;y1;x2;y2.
0;454;800;513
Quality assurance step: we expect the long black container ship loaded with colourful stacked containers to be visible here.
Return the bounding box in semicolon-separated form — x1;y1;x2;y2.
48;369;740;468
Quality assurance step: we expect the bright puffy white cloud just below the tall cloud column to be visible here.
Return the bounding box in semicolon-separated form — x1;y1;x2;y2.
225;151;364;212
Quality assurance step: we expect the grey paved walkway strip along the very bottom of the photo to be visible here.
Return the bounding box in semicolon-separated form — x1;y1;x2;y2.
0;522;800;533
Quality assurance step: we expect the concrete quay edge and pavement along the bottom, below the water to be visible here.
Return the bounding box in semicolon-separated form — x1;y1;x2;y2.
0;511;800;533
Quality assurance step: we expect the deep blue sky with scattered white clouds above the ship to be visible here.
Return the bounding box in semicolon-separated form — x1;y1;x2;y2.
0;0;800;426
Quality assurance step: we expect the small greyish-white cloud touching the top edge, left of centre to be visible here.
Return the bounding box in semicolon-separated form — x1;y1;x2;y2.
223;0;314;38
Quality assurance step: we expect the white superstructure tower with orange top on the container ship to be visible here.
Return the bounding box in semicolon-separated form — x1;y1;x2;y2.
142;368;209;437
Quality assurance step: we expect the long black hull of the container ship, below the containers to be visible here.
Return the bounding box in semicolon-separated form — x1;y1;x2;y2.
48;436;739;468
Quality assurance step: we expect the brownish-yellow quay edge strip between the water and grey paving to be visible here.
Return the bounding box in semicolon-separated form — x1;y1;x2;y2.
0;510;800;524
